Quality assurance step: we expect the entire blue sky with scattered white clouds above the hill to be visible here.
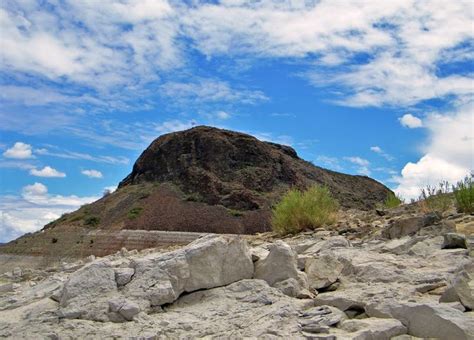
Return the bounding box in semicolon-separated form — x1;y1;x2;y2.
0;0;474;242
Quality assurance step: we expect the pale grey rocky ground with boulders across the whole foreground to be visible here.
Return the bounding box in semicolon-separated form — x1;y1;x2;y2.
0;212;474;339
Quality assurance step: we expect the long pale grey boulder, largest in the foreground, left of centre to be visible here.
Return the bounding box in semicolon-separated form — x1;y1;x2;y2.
60;235;254;321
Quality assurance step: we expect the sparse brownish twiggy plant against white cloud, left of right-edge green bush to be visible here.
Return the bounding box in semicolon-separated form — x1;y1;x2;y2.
418;181;453;214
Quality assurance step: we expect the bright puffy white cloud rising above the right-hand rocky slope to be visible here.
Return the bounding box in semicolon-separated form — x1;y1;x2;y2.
394;103;474;198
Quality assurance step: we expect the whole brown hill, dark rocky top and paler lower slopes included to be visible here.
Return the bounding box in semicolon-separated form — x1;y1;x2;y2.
1;126;390;256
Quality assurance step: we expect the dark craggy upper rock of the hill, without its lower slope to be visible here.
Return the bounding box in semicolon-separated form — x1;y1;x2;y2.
119;126;390;210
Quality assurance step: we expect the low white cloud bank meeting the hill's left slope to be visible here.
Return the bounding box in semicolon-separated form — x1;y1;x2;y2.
0;182;99;242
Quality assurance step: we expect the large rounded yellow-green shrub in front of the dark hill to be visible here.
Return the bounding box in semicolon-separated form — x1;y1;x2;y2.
272;185;339;235
